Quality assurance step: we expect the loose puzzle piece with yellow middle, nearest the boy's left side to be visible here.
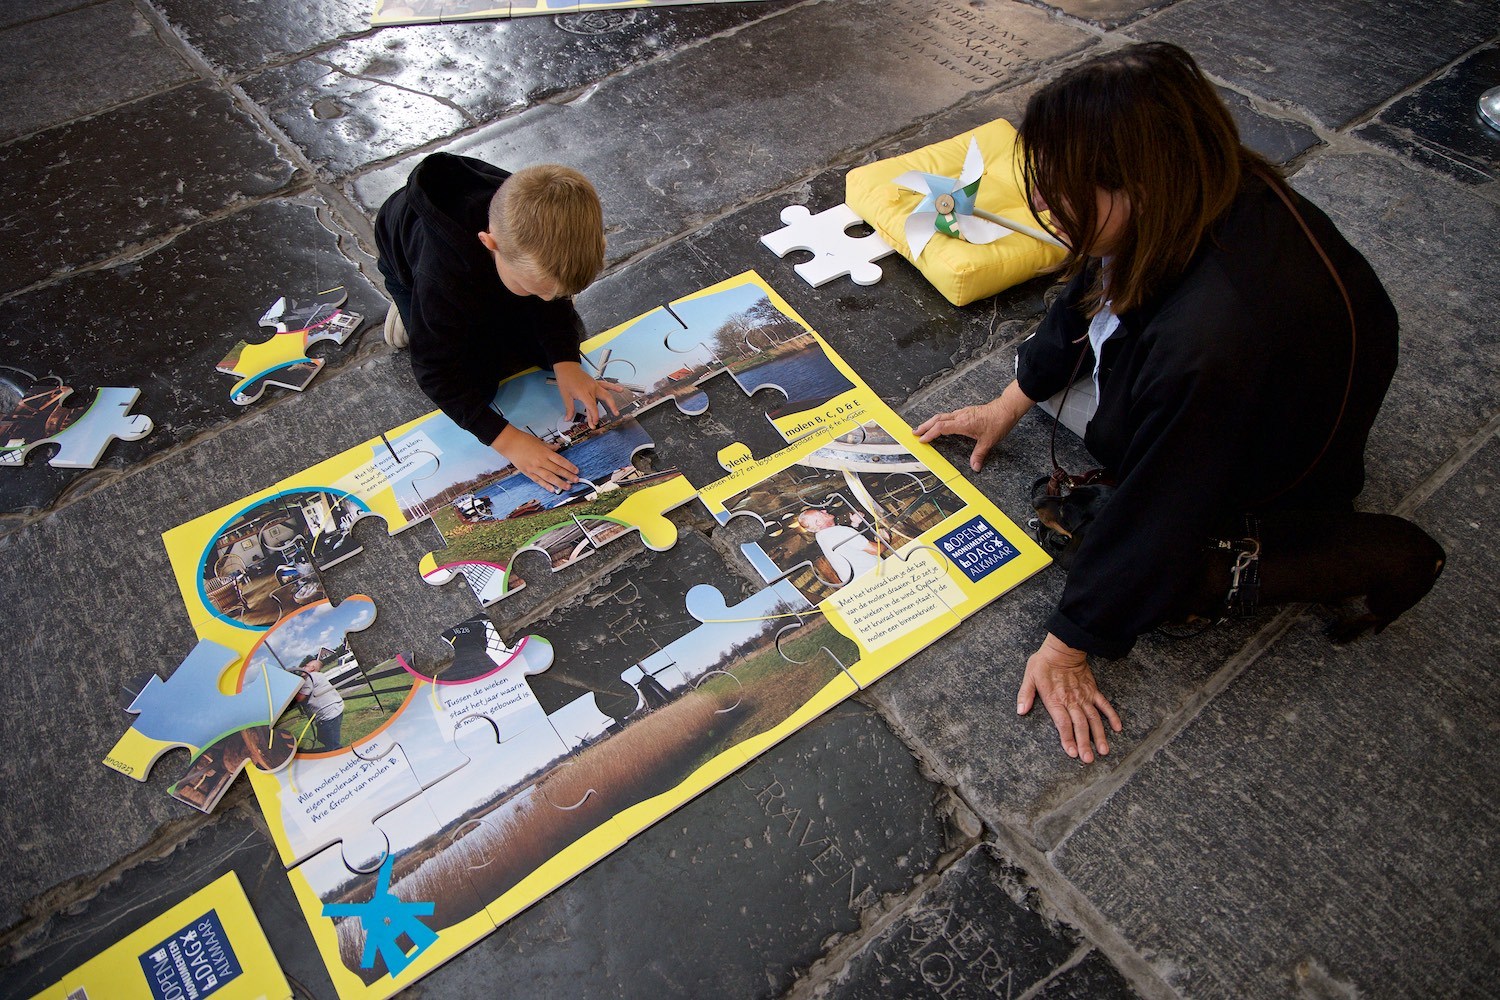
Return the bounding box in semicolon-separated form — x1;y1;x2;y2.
218;285;365;406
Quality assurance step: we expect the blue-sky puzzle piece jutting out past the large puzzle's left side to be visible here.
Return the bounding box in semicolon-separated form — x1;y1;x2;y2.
104;640;302;813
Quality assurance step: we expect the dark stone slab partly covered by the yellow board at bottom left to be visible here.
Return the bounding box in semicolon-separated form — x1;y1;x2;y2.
0;805;333;997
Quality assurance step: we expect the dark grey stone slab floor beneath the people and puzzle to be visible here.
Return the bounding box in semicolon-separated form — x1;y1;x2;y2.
0;0;1500;999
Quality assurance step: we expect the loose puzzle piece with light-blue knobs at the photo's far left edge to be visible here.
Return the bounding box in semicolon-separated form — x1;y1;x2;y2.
0;376;155;469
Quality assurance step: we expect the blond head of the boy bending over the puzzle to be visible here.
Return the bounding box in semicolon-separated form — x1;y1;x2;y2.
489;163;605;295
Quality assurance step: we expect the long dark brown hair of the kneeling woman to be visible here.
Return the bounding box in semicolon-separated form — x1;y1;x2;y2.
1020;42;1281;313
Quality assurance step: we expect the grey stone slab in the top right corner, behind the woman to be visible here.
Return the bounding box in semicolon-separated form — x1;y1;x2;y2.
1128;0;1500;127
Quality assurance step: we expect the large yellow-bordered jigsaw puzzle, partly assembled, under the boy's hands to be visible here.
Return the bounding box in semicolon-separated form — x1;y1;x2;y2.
146;273;1047;999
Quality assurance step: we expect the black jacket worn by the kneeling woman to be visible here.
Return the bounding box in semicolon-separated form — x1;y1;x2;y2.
1017;175;1397;657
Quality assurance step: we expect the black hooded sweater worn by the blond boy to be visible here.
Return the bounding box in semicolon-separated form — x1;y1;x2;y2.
375;153;584;445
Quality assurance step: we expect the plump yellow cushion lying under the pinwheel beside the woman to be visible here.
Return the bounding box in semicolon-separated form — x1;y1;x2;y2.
845;118;1064;306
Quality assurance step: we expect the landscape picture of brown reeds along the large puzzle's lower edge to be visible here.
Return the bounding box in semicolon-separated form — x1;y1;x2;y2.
300;585;858;982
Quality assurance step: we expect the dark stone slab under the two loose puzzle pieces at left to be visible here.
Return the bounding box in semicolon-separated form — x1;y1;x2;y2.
0;199;386;521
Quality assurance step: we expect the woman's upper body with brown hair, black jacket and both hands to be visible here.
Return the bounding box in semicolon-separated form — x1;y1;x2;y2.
918;43;1397;763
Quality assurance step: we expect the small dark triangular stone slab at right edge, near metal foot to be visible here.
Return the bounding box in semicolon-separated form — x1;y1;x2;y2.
1355;45;1500;192
